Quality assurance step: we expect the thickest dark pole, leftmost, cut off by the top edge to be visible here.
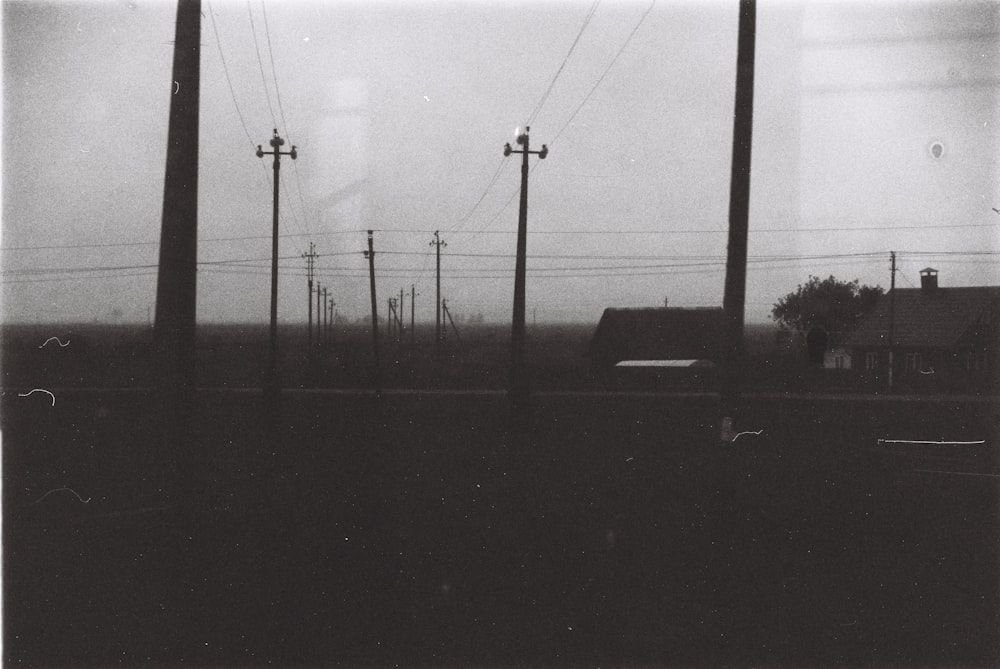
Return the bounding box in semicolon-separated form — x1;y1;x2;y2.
153;0;201;420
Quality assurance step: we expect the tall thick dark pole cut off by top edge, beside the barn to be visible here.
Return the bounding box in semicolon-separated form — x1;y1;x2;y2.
719;0;757;441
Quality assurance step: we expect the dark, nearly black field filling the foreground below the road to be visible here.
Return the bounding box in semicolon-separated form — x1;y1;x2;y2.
2;389;1000;667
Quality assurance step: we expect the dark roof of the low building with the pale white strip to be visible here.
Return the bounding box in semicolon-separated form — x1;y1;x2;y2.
590;307;725;364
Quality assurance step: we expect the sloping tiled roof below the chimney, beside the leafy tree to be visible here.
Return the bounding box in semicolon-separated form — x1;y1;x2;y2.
842;286;1000;348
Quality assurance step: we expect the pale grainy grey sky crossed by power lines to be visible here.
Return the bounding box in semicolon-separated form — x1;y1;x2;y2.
0;0;1000;324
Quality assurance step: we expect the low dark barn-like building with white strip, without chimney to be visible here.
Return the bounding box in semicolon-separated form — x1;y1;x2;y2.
588;307;725;381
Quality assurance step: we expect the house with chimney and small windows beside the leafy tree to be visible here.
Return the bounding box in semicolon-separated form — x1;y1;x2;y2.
842;267;1000;392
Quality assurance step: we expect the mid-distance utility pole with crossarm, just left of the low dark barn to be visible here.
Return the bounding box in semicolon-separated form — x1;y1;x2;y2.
503;127;549;413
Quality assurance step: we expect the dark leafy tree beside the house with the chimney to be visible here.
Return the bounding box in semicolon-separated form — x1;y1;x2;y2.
771;275;885;334
